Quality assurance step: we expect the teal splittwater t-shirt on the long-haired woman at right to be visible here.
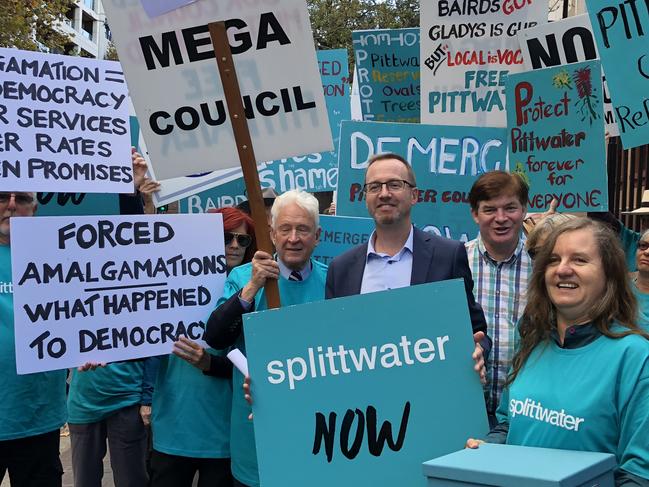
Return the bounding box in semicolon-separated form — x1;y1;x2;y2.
498;329;649;479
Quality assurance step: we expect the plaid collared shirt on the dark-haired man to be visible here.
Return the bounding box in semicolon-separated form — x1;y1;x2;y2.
465;235;532;414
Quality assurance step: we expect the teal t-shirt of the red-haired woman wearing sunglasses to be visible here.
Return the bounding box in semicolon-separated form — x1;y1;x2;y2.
152;349;232;458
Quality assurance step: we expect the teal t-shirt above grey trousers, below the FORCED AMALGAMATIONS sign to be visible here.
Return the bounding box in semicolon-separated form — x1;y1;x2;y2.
68;360;144;424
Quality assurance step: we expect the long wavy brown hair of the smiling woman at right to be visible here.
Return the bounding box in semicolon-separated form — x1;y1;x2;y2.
507;218;649;385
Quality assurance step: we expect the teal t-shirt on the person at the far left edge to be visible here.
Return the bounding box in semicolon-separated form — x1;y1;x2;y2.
0;245;66;441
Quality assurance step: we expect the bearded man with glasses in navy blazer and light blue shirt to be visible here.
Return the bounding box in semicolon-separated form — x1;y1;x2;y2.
325;154;491;380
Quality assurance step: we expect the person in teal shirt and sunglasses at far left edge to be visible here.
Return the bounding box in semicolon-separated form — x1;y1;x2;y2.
0;192;67;487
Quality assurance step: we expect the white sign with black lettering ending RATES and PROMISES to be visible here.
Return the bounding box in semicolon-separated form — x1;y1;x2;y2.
0;48;133;193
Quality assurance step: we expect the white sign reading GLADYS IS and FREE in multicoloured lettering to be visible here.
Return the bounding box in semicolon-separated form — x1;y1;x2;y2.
421;0;548;127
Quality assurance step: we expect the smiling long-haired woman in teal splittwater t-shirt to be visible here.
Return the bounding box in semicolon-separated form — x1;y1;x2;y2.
467;218;649;486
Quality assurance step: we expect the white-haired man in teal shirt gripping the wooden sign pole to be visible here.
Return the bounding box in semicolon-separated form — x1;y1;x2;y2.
203;190;327;487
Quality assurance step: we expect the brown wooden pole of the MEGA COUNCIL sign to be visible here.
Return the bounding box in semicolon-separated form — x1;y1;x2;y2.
208;22;281;309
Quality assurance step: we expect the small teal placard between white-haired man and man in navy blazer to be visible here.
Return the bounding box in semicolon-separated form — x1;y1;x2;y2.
313;215;374;265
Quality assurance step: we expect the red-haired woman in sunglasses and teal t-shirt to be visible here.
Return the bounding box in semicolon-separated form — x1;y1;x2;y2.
150;208;256;487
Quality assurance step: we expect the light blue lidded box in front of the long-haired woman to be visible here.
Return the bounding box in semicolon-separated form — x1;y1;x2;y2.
423;443;617;487
